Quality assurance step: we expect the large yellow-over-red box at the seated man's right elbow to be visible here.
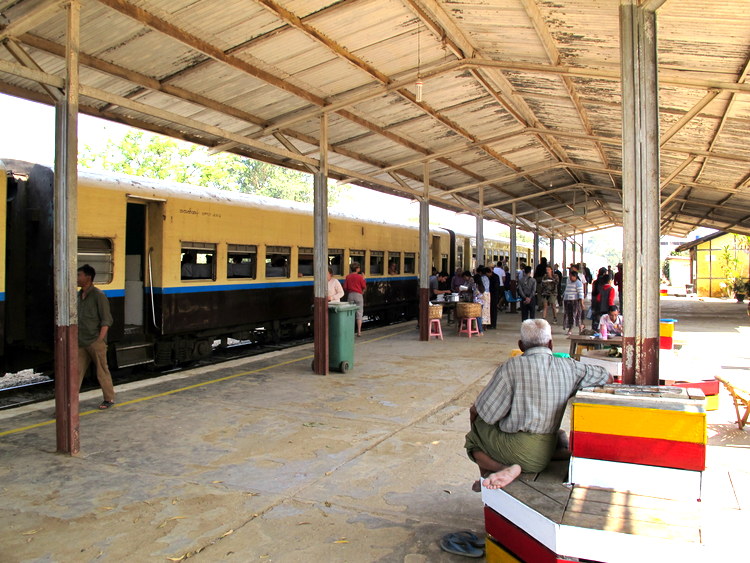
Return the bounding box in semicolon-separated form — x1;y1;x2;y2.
571;386;707;471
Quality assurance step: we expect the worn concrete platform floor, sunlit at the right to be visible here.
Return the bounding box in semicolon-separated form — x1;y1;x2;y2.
0;298;750;563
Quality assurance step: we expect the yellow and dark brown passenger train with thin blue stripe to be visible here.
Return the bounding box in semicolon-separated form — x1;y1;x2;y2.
0;161;530;369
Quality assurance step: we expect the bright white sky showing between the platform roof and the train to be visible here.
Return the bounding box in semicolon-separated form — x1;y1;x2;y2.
0;94;640;262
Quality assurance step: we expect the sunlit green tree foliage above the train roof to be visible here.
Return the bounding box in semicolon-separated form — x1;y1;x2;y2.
79;130;342;203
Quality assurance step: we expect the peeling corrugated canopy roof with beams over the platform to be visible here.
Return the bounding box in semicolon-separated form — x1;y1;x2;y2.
0;0;750;236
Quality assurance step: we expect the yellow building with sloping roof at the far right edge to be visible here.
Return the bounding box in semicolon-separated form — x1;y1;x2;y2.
676;231;750;297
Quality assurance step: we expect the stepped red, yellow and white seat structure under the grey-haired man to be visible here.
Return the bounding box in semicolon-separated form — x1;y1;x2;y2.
482;385;706;563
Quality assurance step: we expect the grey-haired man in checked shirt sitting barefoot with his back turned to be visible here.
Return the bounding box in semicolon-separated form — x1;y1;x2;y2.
464;319;612;490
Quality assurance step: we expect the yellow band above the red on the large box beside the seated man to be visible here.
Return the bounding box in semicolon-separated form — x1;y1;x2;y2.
573;402;707;444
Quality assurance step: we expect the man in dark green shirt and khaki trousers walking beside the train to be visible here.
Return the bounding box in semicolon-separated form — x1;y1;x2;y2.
78;264;115;409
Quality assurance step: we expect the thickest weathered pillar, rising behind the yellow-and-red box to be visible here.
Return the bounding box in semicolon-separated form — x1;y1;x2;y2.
620;0;660;385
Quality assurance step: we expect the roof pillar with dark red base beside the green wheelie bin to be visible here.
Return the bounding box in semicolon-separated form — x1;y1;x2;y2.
313;113;332;375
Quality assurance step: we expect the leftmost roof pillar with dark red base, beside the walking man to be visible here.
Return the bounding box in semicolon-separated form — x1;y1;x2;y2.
53;0;81;455
